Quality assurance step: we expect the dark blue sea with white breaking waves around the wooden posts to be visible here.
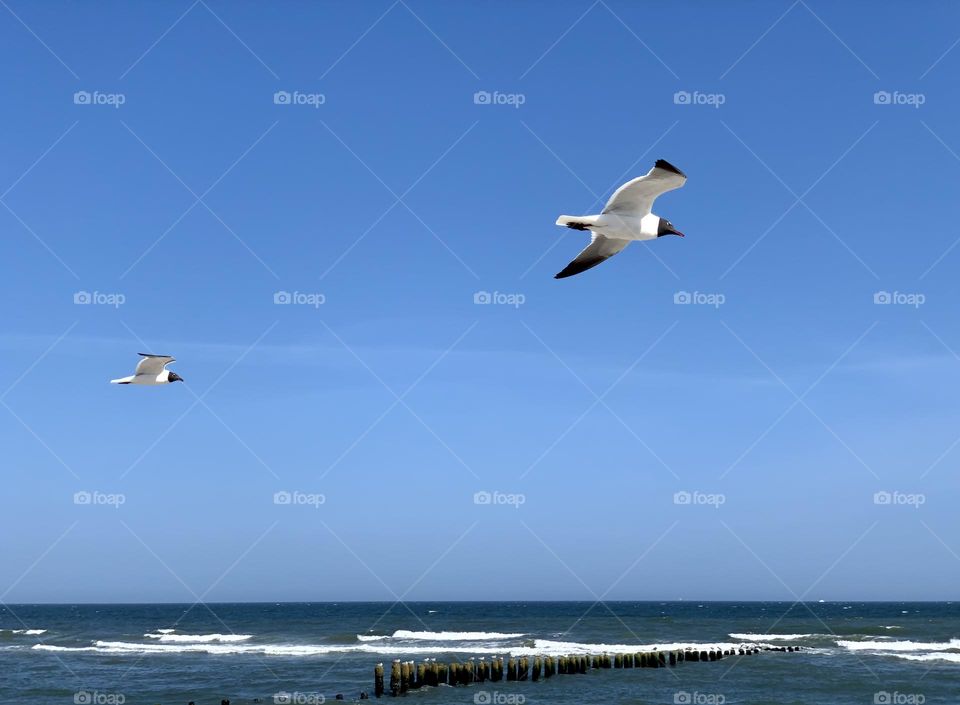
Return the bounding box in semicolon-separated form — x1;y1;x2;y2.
0;601;960;705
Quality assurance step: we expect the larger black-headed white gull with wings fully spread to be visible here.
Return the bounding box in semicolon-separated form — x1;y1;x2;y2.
554;159;687;279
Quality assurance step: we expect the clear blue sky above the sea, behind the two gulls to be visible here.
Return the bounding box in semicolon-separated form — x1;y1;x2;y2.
0;0;960;603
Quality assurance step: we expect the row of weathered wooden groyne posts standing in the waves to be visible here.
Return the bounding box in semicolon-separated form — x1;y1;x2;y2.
373;646;800;698
